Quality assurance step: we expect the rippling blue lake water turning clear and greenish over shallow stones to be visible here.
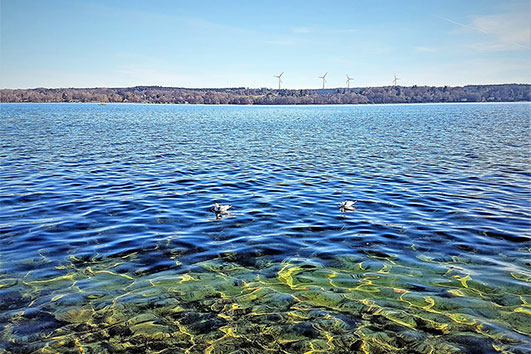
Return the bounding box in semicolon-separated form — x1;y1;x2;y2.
0;104;531;353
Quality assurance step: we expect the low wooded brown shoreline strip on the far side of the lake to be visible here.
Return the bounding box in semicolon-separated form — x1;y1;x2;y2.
0;84;531;105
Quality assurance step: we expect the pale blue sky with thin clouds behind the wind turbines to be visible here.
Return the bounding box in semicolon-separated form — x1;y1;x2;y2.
0;0;531;88
